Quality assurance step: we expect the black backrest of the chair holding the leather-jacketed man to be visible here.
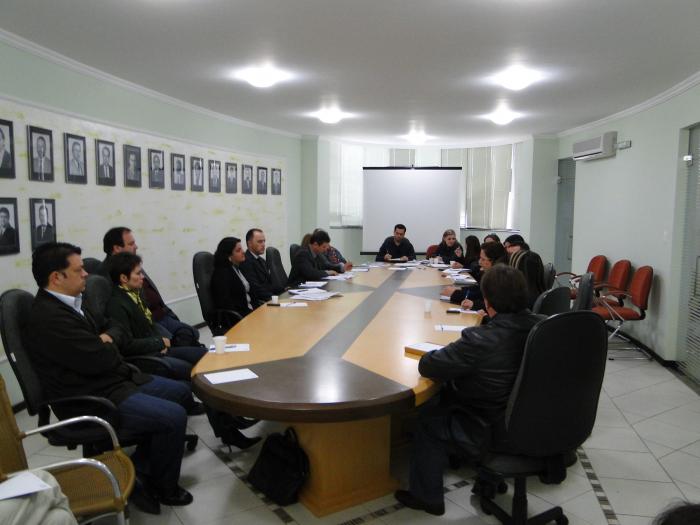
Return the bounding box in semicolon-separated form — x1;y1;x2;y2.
506;311;608;457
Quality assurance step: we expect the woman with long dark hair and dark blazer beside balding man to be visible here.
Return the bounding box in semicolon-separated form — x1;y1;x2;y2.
211;237;260;327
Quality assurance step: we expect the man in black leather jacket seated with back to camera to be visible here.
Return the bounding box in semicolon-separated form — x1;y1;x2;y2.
395;265;544;515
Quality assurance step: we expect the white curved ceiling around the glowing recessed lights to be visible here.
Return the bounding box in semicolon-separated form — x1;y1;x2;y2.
0;0;700;145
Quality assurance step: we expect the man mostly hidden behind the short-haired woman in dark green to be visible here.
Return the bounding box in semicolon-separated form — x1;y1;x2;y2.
99;226;199;346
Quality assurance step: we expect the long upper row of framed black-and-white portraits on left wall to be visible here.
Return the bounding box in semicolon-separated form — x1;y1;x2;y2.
0;119;282;195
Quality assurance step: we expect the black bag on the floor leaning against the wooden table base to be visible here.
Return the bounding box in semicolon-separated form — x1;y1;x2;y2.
248;427;309;505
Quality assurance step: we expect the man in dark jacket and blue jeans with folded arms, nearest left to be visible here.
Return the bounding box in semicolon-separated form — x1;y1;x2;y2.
27;242;192;514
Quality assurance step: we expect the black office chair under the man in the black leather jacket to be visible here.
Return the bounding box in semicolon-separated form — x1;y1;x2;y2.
477;311;608;525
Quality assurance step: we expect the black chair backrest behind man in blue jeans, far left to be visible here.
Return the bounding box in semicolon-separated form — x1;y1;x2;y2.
0;289;44;415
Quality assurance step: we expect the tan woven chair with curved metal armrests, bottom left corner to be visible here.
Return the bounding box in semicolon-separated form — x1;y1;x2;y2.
0;376;136;525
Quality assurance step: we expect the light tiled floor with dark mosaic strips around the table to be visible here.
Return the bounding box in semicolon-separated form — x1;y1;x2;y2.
18;336;700;525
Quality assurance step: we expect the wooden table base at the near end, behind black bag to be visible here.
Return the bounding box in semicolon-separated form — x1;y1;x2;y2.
293;416;398;516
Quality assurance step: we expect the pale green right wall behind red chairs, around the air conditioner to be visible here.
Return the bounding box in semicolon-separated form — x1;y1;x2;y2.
559;86;700;360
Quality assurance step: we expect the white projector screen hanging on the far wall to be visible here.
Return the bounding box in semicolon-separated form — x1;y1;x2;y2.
362;167;462;253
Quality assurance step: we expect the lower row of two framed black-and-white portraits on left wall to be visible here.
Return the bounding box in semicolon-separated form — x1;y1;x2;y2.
0;197;56;255
